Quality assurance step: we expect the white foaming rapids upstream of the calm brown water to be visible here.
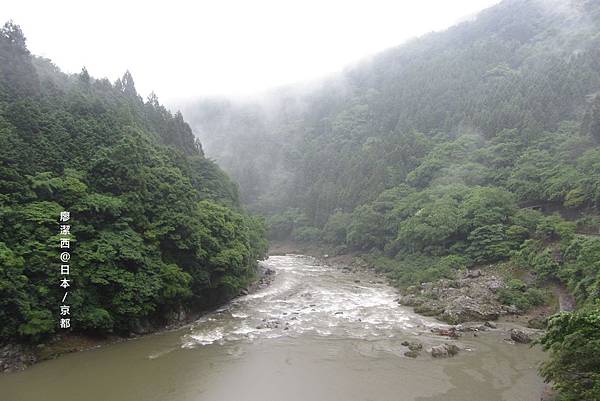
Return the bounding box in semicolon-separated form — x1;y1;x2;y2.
182;255;439;348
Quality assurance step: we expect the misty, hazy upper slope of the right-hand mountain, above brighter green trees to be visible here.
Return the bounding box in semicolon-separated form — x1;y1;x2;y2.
183;0;600;225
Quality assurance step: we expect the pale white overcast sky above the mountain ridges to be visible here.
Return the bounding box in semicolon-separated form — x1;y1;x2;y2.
0;0;498;102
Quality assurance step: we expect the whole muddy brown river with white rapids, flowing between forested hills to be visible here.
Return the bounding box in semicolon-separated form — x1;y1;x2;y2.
0;255;543;401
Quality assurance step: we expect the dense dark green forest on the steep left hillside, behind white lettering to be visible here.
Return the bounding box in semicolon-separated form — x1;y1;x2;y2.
0;22;266;343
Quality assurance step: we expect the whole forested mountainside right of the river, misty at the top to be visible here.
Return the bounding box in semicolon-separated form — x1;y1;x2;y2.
184;0;600;400
